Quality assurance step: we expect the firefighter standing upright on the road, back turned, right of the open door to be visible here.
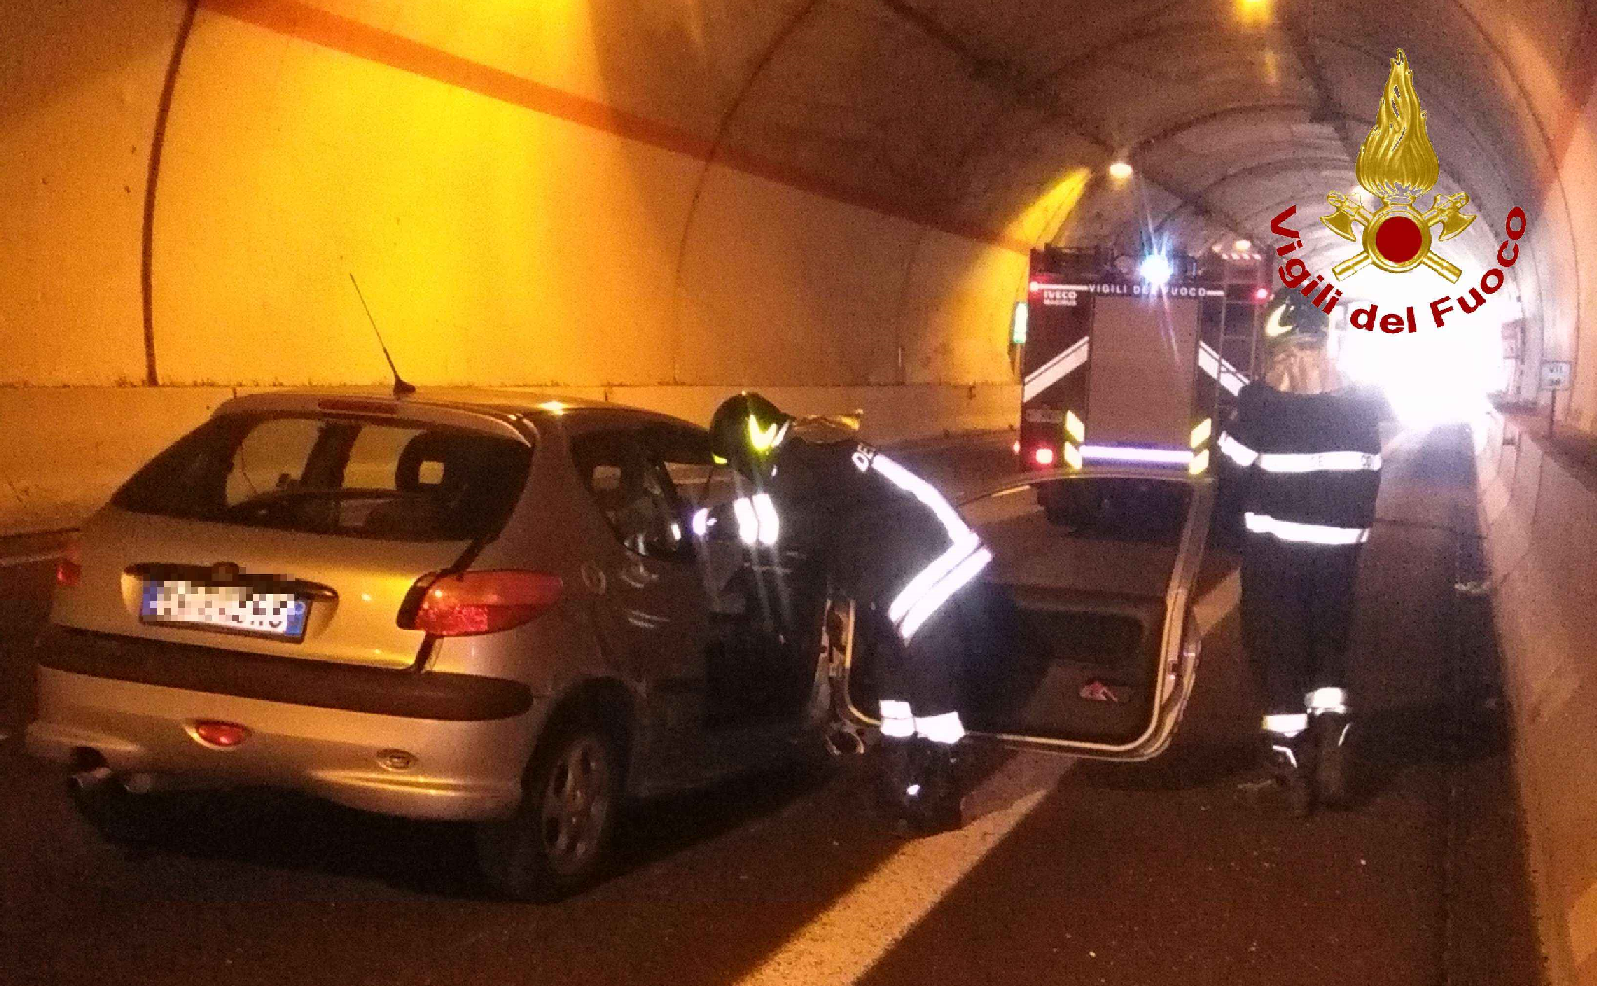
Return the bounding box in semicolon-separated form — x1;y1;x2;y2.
1220;315;1381;815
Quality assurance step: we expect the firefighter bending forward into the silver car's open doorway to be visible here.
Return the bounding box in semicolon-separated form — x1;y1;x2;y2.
696;393;992;831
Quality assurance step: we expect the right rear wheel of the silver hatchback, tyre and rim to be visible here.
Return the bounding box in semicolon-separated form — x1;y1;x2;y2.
476;713;623;901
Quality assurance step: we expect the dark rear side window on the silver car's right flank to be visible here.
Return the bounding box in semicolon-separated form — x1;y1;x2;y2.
572;430;685;559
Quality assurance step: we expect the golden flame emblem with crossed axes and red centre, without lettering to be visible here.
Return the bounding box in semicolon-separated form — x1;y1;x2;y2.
1319;48;1476;281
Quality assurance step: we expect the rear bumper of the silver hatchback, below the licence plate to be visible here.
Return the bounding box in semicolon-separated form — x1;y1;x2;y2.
27;631;545;820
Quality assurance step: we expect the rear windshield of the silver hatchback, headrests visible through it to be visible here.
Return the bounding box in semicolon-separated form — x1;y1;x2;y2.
112;414;532;542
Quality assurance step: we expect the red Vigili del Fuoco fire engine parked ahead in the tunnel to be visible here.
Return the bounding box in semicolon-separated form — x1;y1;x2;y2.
1016;246;1270;485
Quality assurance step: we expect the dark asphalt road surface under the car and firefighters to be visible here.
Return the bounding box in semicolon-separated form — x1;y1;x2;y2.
0;430;1540;986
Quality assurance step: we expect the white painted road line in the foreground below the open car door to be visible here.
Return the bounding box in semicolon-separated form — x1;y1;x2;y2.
738;754;1073;986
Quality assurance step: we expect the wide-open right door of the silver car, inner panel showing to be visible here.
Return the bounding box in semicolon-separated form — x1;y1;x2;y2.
822;467;1214;761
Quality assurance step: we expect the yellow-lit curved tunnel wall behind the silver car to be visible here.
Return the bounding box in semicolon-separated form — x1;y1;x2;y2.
0;2;1057;531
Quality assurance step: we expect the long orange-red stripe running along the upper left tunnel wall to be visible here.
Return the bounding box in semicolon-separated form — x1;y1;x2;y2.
201;0;1033;254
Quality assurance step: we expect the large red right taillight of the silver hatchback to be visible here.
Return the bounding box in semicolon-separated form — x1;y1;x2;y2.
399;572;562;636
